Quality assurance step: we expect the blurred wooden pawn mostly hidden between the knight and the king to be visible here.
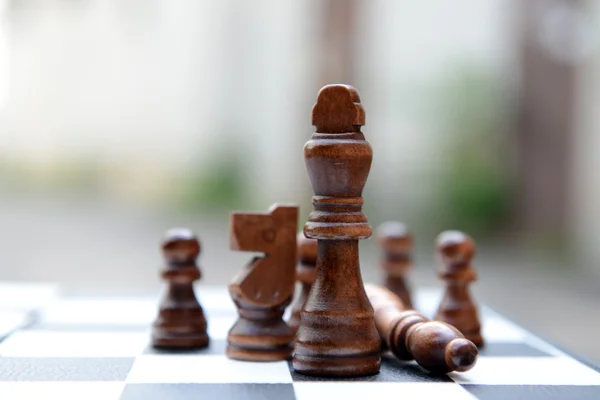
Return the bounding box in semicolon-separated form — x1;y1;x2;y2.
288;232;317;332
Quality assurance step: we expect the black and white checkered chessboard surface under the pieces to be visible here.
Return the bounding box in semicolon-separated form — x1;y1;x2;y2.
0;284;600;400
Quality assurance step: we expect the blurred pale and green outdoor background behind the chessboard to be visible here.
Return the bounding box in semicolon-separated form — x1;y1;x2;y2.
0;0;600;361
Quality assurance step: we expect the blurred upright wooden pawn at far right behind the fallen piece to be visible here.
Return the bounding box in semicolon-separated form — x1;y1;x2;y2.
435;231;483;347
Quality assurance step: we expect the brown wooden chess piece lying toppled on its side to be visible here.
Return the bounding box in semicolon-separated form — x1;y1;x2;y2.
365;284;479;374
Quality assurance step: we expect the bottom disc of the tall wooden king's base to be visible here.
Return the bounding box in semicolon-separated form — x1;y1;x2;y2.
293;354;381;377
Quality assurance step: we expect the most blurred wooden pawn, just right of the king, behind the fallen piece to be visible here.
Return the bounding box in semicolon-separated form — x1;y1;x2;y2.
377;221;414;308
